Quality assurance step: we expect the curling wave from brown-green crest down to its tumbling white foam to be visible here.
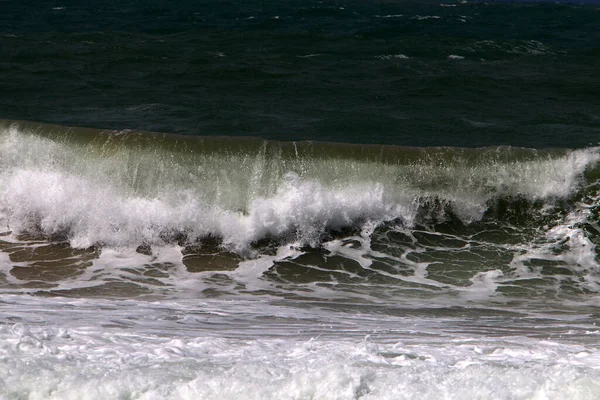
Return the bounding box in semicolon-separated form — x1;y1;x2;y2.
0;121;600;252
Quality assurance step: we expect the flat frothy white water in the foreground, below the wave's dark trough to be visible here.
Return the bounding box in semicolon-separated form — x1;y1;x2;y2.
0;296;600;399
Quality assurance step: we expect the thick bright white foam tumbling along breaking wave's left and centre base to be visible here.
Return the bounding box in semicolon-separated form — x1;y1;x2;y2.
2;170;402;250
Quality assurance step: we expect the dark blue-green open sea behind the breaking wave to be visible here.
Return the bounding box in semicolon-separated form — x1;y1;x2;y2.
0;0;600;148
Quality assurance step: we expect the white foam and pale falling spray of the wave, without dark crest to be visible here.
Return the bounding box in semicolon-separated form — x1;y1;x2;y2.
0;125;600;254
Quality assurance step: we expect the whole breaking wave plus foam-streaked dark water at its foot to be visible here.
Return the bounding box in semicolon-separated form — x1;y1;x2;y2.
0;121;600;302
